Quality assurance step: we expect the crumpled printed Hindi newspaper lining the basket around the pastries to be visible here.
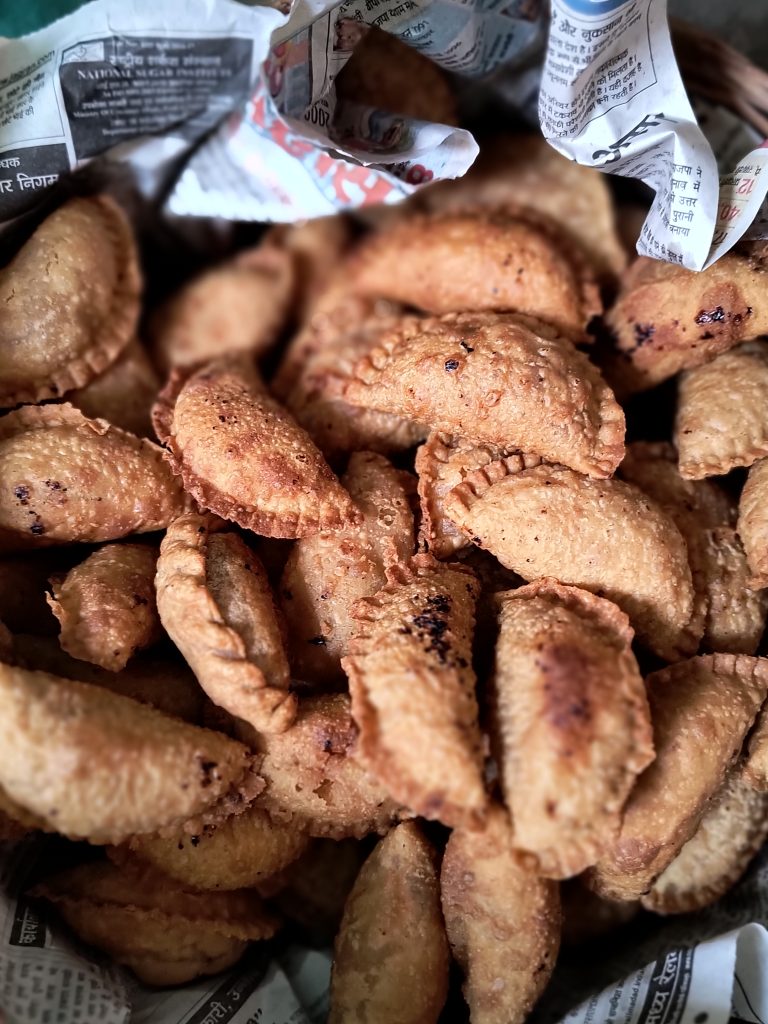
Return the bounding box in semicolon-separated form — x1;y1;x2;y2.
0;0;768;1024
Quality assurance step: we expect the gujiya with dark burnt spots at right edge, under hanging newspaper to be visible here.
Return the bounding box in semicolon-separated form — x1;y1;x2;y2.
606;243;768;392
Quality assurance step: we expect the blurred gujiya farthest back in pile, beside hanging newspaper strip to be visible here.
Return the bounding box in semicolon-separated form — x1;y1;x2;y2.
415;134;634;281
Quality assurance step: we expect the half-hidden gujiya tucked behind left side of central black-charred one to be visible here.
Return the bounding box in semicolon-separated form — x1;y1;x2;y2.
280;452;414;686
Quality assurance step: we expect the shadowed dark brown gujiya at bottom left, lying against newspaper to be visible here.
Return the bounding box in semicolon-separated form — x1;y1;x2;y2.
31;861;279;985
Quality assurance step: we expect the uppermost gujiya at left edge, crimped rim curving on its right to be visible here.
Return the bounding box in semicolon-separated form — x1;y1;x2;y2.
0;196;141;408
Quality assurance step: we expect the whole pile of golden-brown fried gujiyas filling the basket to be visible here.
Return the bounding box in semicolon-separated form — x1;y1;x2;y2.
0;137;768;1024
